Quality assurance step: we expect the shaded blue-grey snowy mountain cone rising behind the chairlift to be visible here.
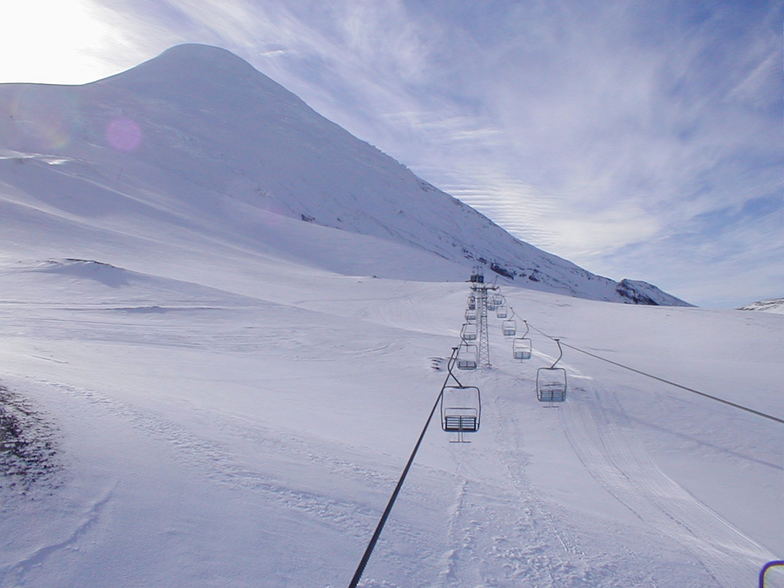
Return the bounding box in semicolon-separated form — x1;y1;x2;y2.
0;44;686;305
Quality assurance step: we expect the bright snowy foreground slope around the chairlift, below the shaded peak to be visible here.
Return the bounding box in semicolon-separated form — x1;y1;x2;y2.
0;255;784;588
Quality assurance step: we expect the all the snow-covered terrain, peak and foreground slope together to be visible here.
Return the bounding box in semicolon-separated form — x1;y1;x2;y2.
0;46;784;588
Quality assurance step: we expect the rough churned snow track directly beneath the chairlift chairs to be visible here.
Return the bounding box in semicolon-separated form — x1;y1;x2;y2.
439;376;591;588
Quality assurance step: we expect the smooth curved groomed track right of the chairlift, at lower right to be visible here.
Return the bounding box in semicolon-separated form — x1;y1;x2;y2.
559;384;773;588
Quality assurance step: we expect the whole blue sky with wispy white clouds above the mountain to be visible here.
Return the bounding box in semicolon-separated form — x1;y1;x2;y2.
0;0;784;306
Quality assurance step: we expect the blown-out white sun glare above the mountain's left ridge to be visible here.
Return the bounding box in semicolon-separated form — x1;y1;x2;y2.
0;0;121;84
